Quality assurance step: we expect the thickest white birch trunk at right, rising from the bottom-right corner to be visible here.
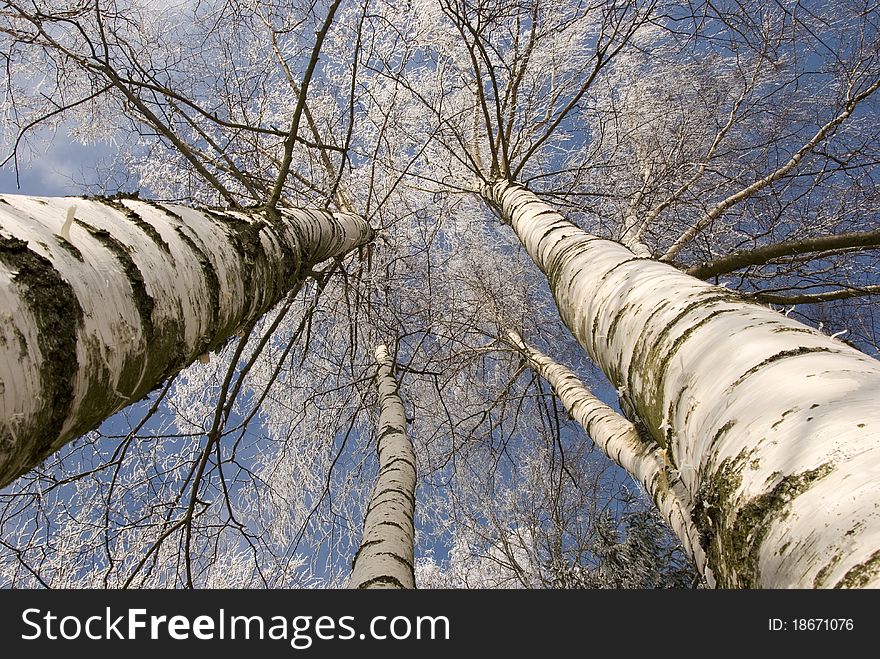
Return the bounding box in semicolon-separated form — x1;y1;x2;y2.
483;182;880;588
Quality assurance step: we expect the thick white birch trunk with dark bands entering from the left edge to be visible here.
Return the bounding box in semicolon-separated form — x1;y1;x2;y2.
0;195;373;486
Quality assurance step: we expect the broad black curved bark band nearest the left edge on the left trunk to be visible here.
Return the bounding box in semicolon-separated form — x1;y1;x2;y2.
0;236;83;485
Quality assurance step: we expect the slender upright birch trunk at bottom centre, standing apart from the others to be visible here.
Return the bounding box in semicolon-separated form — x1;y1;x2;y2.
349;345;416;588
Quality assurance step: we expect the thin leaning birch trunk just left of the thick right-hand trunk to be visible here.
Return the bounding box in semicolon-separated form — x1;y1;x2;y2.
507;331;714;585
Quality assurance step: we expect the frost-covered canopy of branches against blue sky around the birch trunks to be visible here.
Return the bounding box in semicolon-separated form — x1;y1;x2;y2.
0;0;880;587
